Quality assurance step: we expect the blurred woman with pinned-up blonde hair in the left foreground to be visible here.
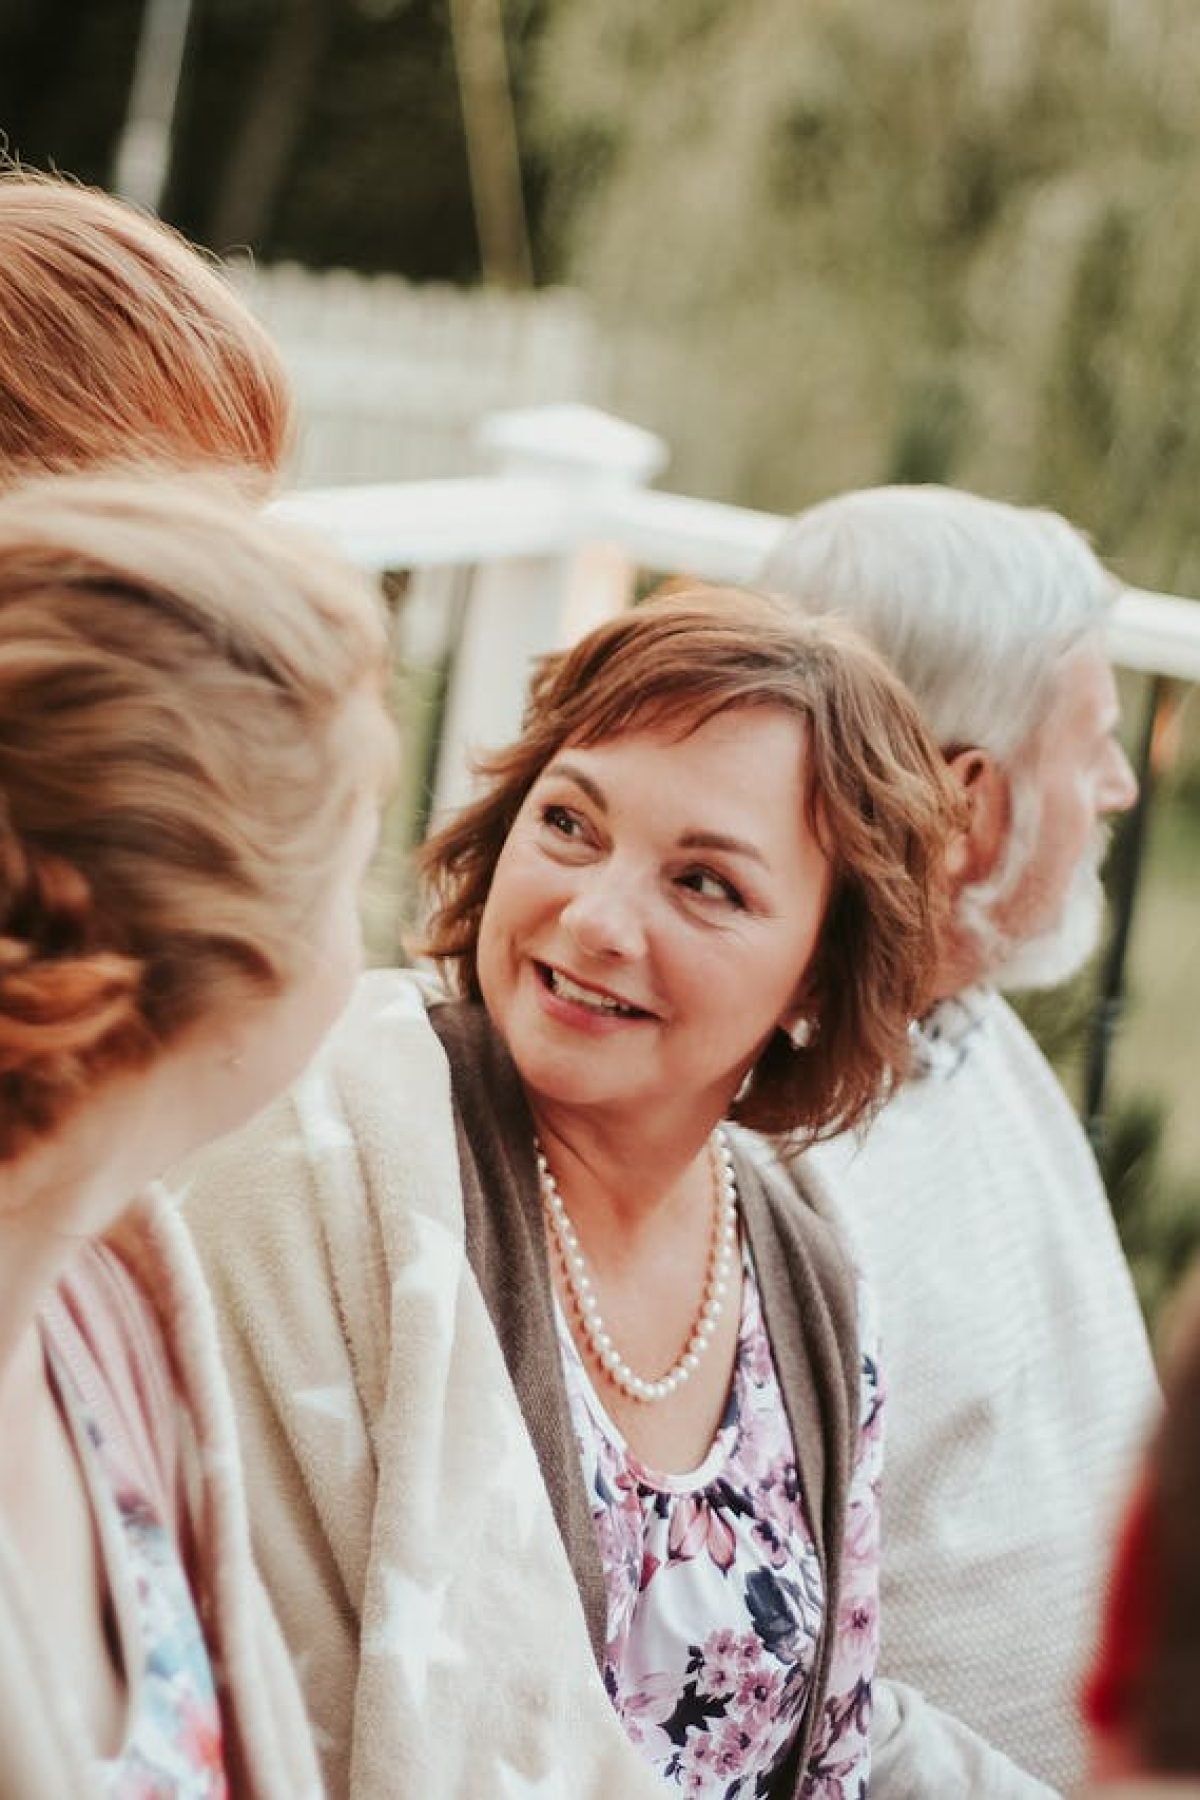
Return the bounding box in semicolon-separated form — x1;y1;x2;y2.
0;475;392;1800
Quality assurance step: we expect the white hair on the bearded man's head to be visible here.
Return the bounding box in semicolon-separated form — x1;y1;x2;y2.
759;486;1117;761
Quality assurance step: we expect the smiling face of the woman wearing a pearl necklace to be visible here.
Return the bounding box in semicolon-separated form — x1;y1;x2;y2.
479;707;829;1129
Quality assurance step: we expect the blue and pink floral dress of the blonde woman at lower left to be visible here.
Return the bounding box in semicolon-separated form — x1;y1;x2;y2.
49;1355;228;1800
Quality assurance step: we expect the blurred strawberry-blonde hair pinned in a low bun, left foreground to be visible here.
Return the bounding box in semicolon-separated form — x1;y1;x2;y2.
0;475;394;1161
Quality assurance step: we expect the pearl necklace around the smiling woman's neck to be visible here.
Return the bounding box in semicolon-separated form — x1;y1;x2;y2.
534;1125;738;1404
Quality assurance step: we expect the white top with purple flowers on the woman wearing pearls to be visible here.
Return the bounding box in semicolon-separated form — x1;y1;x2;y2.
558;1251;882;1800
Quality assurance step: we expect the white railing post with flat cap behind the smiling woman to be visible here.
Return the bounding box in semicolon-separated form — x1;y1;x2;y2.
434;405;667;814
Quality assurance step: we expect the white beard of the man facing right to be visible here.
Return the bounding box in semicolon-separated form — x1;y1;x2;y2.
959;785;1108;990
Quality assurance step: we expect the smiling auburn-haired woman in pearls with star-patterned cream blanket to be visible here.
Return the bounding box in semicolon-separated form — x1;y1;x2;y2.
191;589;957;1800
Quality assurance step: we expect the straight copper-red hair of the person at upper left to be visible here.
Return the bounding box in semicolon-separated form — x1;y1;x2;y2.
0;169;293;488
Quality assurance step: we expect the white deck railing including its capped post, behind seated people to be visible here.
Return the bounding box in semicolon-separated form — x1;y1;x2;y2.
271;407;1200;806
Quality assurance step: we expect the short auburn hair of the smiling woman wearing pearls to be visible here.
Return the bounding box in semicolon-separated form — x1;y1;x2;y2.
421;583;961;1139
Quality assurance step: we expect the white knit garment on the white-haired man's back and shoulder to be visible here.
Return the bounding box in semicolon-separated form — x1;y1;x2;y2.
804;990;1157;1800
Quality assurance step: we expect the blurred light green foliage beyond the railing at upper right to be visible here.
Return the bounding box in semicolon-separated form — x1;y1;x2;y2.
531;0;1200;592
